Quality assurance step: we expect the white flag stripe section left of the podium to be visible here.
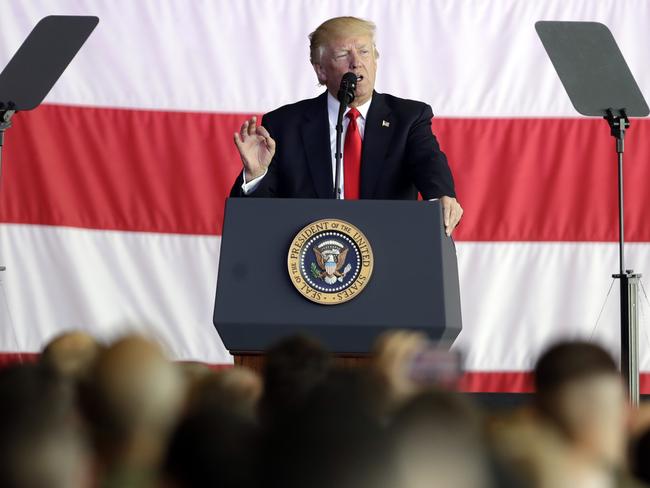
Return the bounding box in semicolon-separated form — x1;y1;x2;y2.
0;224;232;363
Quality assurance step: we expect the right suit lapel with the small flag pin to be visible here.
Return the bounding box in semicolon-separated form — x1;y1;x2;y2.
360;92;394;198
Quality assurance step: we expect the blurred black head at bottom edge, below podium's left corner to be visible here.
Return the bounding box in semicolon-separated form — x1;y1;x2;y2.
161;406;259;488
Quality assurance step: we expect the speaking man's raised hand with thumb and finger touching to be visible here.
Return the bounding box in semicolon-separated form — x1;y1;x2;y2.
234;117;275;181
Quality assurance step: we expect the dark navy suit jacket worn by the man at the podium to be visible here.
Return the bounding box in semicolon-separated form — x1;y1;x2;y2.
230;92;456;200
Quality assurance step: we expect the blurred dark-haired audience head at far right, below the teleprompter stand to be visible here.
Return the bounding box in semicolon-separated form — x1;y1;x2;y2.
535;341;628;466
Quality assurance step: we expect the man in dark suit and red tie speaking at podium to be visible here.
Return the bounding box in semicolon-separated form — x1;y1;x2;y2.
231;17;463;234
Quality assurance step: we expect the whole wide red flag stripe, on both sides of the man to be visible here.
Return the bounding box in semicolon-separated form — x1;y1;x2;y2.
0;105;650;242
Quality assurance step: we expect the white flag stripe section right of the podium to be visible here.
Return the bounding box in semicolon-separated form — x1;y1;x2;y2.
456;242;650;371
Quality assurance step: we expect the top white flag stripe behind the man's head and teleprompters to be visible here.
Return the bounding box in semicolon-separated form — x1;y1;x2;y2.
0;0;650;117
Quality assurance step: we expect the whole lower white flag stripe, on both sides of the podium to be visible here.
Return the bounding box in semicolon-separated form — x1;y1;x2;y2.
0;225;650;371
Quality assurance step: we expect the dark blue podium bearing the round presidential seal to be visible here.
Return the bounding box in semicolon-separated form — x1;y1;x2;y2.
213;198;462;369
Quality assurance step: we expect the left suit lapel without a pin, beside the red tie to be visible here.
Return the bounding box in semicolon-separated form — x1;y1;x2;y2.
301;92;334;198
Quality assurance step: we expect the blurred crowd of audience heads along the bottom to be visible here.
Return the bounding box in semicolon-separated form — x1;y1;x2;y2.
0;331;650;488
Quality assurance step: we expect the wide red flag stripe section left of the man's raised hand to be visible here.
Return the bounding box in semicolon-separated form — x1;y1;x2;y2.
0;105;251;234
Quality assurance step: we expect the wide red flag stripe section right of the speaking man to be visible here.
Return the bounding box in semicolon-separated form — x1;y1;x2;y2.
433;119;650;242
